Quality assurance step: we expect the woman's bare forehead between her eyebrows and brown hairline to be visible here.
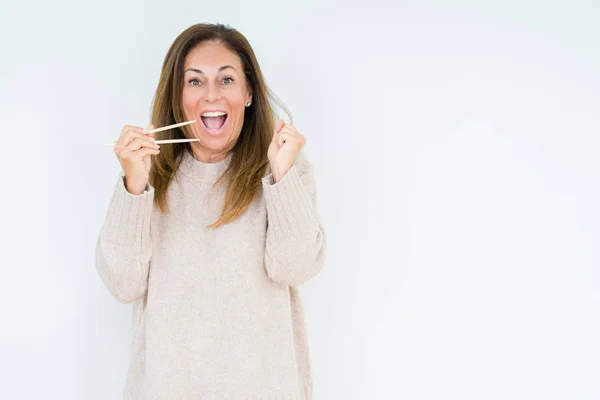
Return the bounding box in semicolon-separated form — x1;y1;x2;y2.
184;42;242;72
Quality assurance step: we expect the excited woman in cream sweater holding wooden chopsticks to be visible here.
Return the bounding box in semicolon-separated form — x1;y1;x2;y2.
96;24;326;400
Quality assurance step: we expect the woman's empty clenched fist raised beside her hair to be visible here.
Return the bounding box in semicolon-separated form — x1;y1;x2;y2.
268;119;306;183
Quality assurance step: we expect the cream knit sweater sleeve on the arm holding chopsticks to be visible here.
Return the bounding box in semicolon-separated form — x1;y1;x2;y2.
96;176;154;303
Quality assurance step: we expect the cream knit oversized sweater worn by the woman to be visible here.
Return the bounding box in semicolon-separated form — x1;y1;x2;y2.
96;152;326;400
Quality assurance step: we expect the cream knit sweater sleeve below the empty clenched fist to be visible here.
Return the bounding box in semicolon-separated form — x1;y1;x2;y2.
263;153;327;286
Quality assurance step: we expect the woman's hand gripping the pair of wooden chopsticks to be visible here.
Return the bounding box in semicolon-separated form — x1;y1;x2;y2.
114;125;160;194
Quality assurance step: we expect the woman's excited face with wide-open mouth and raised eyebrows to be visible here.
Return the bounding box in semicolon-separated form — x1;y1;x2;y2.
182;42;252;162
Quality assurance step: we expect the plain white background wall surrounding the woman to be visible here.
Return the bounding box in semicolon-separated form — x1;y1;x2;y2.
0;0;600;400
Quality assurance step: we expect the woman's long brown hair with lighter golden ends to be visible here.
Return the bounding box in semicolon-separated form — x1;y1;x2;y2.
150;24;291;228
